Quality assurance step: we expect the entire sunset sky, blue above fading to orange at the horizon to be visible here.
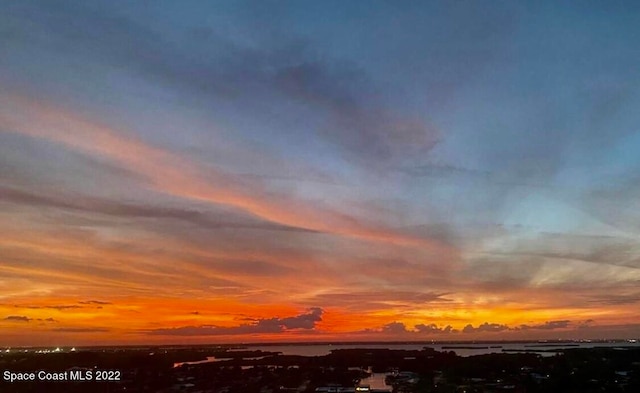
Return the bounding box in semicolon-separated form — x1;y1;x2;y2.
0;0;640;346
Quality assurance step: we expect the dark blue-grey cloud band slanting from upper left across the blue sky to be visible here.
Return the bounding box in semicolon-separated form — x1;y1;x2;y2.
2;0;438;166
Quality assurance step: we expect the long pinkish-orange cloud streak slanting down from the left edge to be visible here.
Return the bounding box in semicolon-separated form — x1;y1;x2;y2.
0;94;455;257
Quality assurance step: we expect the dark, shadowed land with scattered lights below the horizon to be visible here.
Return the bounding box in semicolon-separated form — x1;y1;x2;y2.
0;347;640;393
